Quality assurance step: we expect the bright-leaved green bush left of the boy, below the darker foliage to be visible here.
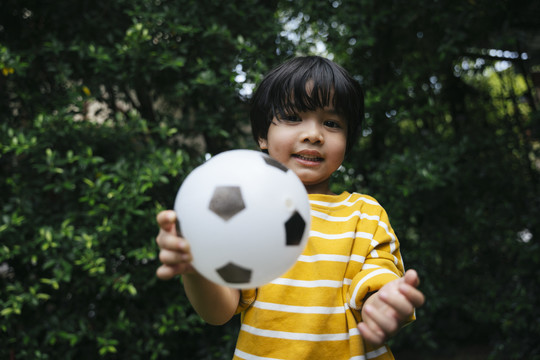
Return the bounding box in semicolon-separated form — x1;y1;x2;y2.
0;107;240;359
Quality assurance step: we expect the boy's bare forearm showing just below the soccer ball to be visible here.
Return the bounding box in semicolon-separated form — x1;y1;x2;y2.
182;272;240;325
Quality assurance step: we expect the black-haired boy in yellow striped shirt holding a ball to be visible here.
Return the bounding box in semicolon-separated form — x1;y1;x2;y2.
156;56;424;360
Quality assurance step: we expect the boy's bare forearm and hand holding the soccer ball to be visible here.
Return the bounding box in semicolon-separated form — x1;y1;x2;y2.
156;211;240;325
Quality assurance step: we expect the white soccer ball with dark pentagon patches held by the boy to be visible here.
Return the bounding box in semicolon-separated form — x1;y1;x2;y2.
174;150;311;289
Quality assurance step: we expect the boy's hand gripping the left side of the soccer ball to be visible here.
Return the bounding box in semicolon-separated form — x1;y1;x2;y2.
156;210;195;280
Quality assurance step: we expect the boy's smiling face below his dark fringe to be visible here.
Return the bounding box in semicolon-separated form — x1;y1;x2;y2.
259;107;347;194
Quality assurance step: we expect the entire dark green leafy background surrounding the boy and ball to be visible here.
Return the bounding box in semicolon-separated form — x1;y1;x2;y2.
0;0;540;360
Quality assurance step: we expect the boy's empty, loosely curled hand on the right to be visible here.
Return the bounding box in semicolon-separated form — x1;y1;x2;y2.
358;270;425;346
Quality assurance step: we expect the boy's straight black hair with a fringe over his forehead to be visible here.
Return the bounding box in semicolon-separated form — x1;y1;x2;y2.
250;56;364;153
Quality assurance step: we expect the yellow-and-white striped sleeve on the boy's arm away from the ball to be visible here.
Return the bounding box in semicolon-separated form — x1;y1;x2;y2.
347;205;404;310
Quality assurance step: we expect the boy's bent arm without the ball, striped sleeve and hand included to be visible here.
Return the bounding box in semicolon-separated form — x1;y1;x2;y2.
349;204;424;346
